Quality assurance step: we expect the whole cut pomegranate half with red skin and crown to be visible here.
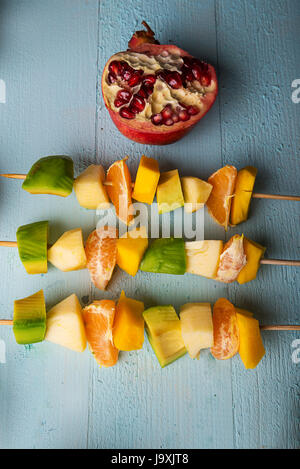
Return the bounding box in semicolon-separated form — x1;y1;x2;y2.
102;22;218;145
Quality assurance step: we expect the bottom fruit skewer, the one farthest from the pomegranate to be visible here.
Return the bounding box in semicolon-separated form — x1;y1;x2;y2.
0;290;300;369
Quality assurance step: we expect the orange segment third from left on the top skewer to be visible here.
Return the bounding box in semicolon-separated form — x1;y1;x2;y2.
106;157;133;225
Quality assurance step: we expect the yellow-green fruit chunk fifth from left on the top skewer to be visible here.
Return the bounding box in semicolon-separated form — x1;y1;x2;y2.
156;169;184;213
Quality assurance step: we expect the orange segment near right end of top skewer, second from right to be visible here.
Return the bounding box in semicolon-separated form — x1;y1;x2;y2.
207;166;237;230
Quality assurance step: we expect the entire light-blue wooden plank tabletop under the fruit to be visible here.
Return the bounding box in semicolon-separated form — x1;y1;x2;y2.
0;0;300;448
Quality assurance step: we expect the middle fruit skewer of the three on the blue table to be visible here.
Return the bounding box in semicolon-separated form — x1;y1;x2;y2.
0;221;300;290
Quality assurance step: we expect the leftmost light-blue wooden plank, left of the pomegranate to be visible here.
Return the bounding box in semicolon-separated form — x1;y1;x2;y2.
0;1;98;448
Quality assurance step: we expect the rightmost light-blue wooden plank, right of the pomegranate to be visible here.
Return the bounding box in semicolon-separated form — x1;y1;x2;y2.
216;1;300;448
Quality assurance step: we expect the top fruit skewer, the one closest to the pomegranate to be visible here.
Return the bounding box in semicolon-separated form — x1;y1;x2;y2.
1;156;300;229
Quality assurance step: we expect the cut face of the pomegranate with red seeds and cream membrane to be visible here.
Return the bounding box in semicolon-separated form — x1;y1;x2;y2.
103;51;216;125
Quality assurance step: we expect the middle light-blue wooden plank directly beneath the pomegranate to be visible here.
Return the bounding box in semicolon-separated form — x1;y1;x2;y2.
89;0;233;448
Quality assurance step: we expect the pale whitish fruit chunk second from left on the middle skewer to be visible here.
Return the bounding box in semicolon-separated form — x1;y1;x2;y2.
48;228;86;272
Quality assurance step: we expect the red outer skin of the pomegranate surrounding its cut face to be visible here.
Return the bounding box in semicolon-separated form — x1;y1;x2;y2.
102;43;218;145
